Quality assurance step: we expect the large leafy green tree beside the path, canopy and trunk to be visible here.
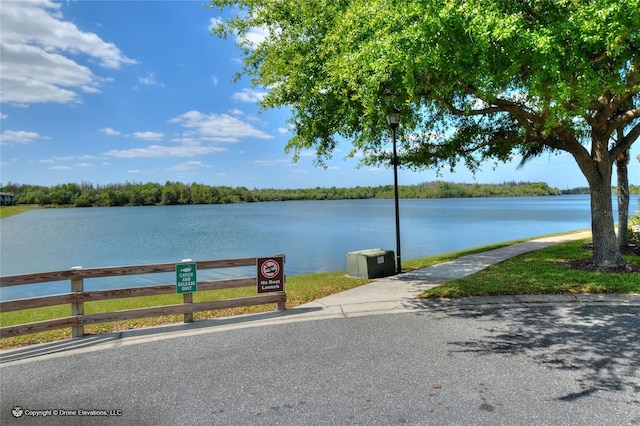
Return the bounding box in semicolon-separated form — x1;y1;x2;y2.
211;0;640;268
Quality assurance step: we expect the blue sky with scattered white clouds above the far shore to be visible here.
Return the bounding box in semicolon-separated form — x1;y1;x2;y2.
0;0;640;189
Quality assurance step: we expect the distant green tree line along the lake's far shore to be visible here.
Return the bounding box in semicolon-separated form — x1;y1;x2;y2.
1;181;640;207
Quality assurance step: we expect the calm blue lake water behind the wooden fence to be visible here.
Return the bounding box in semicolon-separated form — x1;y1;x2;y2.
0;195;638;300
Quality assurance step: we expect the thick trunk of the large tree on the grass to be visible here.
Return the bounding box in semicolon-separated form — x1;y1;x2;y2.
585;155;626;269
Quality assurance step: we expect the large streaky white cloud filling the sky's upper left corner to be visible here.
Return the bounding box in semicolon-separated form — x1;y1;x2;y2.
0;0;136;104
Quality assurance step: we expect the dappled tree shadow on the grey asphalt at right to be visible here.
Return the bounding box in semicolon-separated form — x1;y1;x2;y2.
410;303;640;407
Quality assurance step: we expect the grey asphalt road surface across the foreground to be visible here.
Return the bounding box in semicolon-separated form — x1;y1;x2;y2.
0;302;640;426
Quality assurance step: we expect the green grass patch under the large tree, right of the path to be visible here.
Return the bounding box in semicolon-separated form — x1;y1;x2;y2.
419;241;640;299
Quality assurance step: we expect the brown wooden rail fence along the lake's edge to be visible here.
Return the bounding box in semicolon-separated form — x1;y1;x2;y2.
0;255;287;338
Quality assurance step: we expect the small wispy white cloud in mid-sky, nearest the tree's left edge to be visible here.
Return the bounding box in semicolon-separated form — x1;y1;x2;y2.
169;111;273;142
